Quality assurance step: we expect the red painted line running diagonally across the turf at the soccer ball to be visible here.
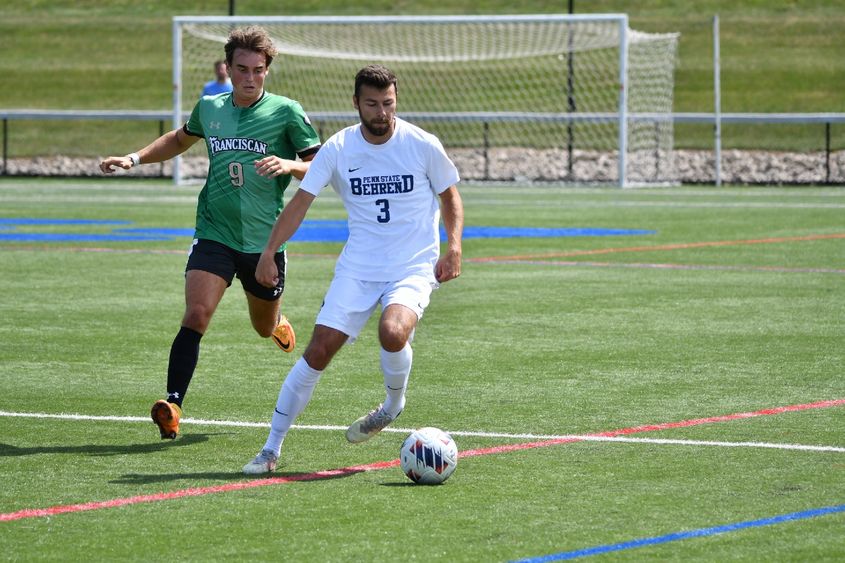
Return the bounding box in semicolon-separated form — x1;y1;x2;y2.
0;399;845;522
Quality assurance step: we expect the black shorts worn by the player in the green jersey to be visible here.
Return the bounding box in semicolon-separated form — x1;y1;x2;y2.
185;239;288;301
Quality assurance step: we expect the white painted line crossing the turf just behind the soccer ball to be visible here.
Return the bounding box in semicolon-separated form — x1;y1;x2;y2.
0;411;845;453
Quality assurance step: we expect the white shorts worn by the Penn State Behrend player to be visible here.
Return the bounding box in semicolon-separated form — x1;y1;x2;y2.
315;276;438;342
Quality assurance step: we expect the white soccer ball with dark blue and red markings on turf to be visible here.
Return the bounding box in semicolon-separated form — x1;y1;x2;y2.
399;427;458;485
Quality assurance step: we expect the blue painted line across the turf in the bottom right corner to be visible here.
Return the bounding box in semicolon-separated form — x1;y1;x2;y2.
513;504;845;563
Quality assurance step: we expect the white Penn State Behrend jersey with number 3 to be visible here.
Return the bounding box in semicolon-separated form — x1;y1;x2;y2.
299;117;459;281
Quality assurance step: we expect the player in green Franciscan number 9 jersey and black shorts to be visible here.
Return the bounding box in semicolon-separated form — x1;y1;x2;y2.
100;27;320;439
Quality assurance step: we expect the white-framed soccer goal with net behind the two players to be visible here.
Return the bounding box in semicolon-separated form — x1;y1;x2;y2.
173;14;678;186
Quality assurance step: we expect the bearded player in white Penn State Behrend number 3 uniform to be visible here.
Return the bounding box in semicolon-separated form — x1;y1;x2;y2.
243;65;463;474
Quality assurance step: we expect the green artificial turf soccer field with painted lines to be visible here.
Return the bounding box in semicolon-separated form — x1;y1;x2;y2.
0;179;845;561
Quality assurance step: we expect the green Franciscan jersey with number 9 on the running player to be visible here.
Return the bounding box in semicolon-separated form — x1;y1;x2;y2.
185;92;320;253
